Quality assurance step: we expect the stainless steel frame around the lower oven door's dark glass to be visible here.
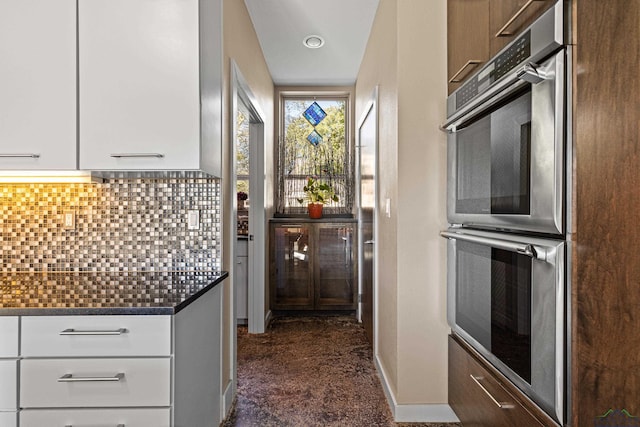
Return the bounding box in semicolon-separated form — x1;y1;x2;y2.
441;229;566;424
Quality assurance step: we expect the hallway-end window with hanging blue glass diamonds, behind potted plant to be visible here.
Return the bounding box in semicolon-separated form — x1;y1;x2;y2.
277;95;353;214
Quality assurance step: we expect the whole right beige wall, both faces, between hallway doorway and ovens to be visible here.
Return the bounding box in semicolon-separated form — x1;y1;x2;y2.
356;0;449;405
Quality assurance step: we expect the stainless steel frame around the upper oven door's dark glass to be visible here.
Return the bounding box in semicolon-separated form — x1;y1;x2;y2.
447;50;569;235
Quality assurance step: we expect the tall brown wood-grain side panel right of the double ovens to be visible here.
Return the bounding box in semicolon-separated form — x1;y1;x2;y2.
569;0;640;426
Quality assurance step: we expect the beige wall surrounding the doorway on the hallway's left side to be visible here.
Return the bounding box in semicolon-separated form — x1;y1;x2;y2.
222;0;275;387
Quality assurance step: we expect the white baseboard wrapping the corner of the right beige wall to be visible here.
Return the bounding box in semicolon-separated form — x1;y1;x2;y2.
375;355;460;423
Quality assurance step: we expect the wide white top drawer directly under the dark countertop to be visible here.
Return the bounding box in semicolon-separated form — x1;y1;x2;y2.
21;316;171;357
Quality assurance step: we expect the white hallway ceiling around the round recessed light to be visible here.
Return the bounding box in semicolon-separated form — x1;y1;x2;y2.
245;0;379;86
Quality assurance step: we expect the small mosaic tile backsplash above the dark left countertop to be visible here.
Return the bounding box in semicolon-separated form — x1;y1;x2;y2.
0;178;221;272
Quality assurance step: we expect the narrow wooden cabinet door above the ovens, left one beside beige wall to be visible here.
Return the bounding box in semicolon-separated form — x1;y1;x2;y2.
447;0;489;93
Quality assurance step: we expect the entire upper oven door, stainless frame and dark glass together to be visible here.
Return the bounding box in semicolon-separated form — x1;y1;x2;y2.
444;50;565;235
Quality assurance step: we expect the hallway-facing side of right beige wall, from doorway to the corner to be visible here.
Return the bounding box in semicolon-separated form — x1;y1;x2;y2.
356;0;398;393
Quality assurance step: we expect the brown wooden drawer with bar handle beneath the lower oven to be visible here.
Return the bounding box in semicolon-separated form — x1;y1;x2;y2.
449;335;558;427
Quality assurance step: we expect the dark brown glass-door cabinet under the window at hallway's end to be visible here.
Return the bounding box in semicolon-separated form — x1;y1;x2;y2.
269;222;357;310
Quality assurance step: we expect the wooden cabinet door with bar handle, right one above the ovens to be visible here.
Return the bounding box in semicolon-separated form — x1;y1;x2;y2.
489;0;556;57
